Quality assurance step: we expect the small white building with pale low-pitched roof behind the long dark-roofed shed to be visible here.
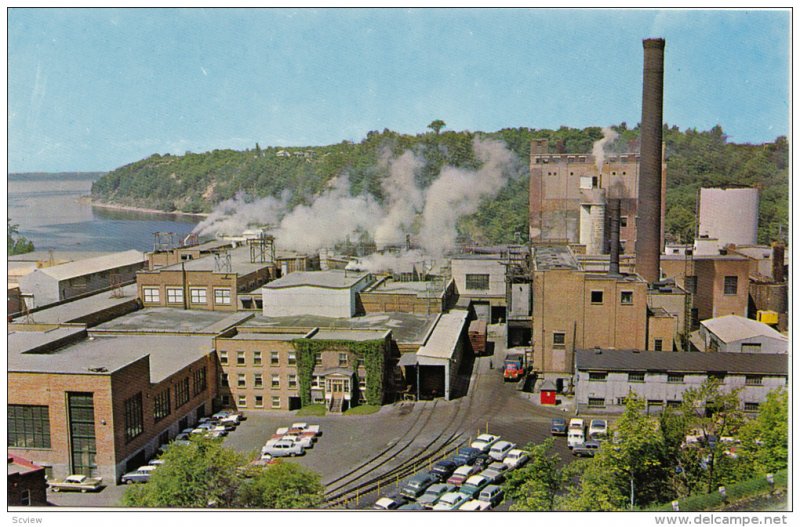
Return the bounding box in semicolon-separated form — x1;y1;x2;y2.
692;315;789;354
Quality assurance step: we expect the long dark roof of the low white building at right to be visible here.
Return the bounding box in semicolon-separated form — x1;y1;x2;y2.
575;349;789;375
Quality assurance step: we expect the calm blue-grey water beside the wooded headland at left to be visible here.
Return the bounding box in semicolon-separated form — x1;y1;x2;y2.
8;174;199;251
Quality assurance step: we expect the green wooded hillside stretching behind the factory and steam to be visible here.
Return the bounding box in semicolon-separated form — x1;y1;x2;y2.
92;125;789;243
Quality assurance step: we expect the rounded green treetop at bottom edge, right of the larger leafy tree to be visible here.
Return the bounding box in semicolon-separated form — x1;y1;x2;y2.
238;461;325;509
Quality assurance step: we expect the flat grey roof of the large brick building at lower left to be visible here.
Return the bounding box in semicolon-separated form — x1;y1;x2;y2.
8;335;213;383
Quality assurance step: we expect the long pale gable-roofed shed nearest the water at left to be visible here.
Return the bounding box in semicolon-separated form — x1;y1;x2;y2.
19;250;147;309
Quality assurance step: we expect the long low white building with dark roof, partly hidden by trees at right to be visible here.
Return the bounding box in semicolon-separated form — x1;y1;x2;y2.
575;349;789;414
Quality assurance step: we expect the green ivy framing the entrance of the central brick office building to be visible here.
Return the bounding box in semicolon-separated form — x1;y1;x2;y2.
292;339;386;406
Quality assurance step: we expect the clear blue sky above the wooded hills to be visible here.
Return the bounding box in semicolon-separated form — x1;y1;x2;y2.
8;9;790;172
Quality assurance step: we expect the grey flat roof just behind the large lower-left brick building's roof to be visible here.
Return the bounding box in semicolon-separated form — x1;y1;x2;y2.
92;307;253;335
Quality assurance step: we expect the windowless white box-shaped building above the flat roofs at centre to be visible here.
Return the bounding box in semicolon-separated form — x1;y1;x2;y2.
261;270;374;318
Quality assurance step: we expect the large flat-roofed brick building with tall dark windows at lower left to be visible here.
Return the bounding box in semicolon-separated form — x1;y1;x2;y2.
8;325;217;482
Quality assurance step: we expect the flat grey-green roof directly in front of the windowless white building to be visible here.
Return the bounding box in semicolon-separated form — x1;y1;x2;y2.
242;312;437;345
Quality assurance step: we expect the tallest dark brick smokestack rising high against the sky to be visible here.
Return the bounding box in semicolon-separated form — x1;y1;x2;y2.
636;38;664;283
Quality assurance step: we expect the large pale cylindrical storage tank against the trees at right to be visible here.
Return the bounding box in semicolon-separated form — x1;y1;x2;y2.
698;188;758;248
